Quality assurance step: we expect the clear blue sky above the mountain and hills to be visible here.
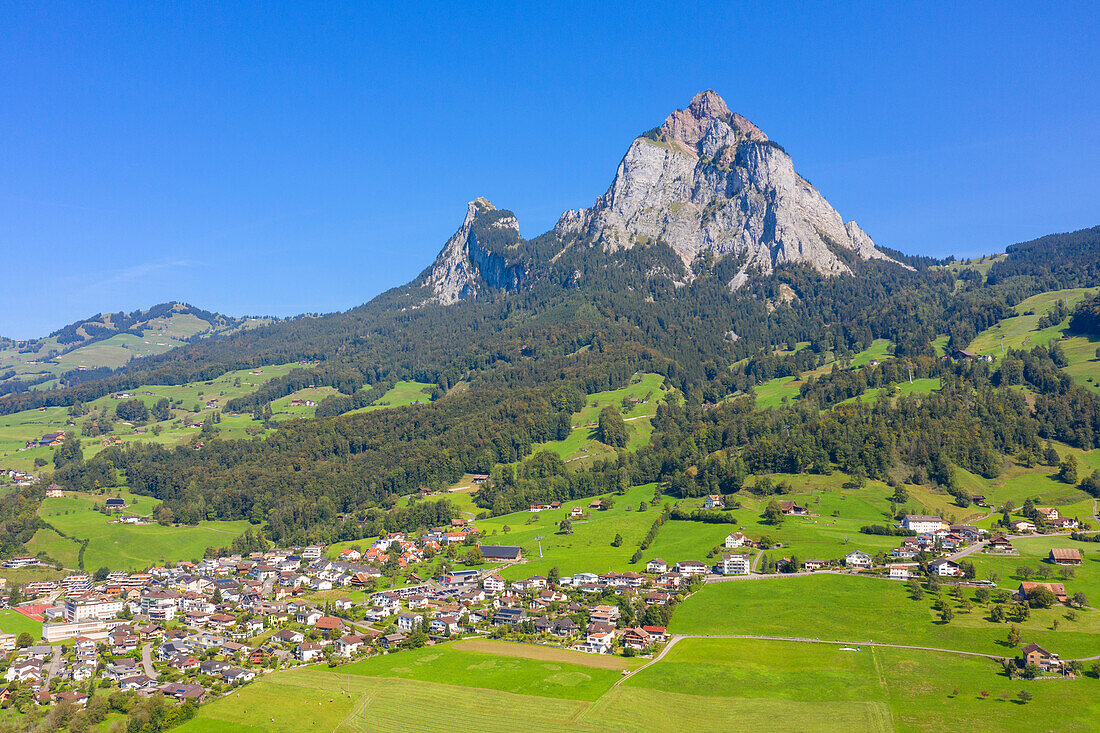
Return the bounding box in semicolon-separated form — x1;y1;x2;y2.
0;2;1100;338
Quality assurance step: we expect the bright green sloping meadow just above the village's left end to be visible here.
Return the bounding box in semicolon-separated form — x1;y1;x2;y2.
28;492;249;570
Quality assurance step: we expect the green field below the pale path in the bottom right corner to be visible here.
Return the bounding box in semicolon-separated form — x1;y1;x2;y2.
611;639;1100;731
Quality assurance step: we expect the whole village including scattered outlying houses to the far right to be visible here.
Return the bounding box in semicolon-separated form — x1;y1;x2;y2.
0;485;1081;705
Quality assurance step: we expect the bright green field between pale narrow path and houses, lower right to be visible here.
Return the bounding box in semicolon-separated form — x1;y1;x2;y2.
670;575;1100;658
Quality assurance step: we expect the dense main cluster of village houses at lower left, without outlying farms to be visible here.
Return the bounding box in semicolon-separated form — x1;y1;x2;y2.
0;532;708;704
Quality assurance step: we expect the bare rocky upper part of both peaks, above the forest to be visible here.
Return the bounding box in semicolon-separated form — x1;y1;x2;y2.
420;89;911;305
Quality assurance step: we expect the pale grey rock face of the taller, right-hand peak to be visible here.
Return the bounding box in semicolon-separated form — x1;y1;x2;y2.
556;90;904;288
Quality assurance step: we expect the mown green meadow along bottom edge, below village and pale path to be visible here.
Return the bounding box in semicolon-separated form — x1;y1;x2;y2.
173;639;1100;733
